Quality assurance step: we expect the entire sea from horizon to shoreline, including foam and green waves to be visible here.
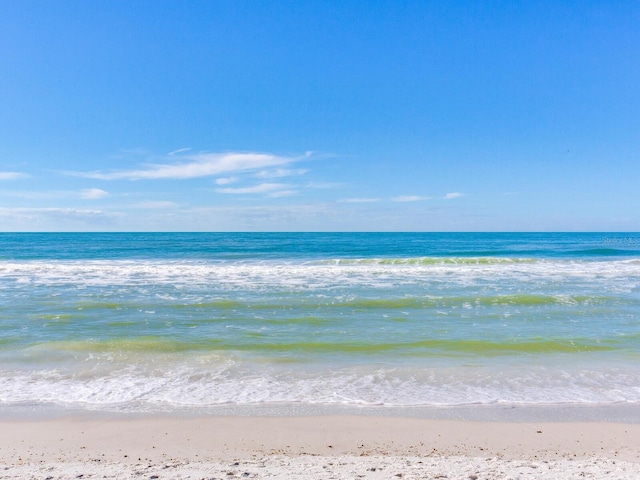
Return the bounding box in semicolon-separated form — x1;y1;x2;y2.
0;233;640;412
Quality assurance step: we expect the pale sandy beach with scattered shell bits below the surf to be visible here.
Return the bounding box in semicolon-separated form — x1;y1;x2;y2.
0;415;640;480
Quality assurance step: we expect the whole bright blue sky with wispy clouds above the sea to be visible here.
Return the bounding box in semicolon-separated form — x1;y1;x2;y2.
0;0;640;231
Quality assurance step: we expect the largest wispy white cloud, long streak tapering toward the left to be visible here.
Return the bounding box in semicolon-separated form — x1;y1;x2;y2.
72;153;308;180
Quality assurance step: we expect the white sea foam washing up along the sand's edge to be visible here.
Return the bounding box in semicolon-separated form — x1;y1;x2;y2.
0;356;640;411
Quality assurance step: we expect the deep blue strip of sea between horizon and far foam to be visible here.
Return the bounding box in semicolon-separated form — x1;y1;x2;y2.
0;233;640;260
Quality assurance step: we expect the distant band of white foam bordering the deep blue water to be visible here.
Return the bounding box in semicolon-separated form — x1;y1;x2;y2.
0;259;640;291
